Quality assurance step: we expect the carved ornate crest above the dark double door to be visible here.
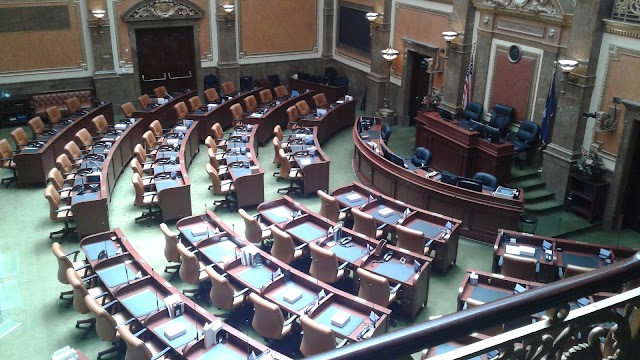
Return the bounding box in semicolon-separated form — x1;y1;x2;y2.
122;0;205;22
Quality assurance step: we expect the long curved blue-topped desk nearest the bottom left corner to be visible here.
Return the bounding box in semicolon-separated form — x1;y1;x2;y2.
80;228;288;359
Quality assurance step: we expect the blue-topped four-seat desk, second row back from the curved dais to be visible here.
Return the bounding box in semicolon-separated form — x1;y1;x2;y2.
258;196;432;321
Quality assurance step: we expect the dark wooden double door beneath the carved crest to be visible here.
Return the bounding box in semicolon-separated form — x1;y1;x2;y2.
136;26;196;95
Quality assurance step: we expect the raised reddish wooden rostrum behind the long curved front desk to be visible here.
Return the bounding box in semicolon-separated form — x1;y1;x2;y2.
415;111;515;185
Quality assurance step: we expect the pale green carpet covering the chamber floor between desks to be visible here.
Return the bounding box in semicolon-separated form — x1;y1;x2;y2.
0;119;640;359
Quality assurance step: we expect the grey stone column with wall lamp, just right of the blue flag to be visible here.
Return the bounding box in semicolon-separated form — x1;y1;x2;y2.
542;0;612;200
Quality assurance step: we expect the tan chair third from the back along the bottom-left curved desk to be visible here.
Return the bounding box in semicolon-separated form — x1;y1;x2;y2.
84;295;129;360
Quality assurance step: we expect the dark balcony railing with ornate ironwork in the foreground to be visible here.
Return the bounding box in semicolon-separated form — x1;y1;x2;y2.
312;252;640;360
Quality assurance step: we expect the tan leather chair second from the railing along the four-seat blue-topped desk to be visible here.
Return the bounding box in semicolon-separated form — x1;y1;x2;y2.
249;293;297;341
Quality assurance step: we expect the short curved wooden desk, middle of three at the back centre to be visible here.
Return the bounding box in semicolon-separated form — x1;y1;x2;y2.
242;91;316;146
